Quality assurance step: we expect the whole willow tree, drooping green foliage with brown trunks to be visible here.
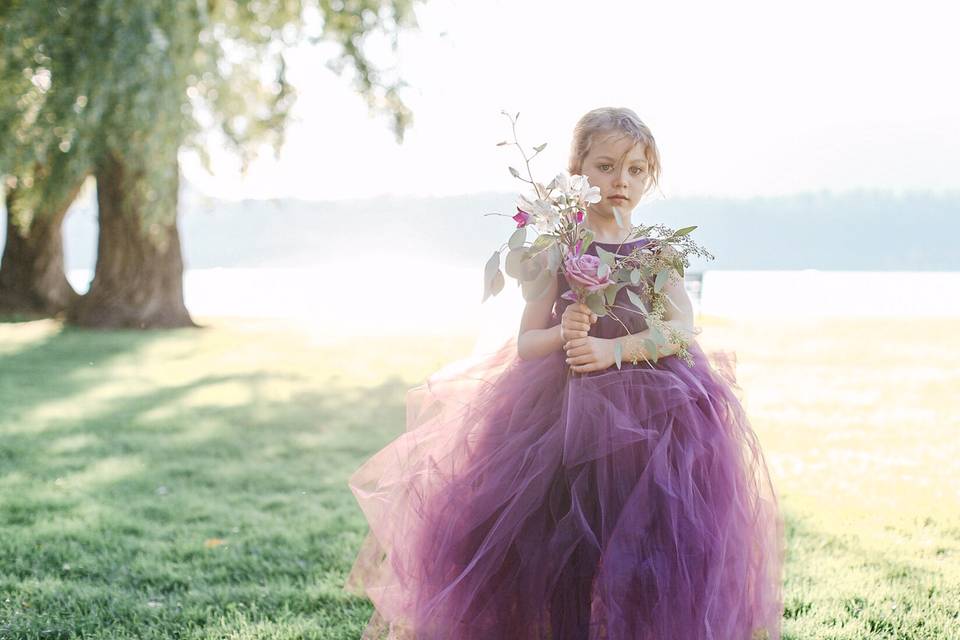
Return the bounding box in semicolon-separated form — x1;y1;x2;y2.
0;0;416;328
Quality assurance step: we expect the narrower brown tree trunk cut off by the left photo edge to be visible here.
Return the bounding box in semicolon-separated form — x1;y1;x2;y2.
0;180;83;317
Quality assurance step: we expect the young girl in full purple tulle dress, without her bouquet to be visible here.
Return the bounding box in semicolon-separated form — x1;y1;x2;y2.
345;108;784;640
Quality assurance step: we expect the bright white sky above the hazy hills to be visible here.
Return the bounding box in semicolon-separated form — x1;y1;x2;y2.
183;0;960;200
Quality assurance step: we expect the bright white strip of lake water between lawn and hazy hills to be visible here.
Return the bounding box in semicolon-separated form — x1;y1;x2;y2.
68;259;960;342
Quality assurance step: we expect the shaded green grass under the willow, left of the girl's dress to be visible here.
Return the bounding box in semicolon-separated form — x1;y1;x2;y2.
0;331;407;638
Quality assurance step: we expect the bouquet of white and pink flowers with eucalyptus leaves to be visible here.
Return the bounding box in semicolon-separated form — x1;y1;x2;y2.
483;112;713;369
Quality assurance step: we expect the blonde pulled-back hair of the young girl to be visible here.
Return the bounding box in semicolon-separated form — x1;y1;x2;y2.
567;107;660;197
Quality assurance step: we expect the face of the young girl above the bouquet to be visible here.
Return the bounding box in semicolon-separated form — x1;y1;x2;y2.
580;132;648;224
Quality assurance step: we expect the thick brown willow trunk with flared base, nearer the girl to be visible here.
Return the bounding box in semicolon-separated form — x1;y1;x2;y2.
67;155;198;329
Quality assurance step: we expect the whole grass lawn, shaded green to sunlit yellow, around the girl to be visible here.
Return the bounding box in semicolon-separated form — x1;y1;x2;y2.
0;318;960;640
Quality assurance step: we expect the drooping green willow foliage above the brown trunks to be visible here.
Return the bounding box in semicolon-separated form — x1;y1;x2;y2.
0;0;416;235
